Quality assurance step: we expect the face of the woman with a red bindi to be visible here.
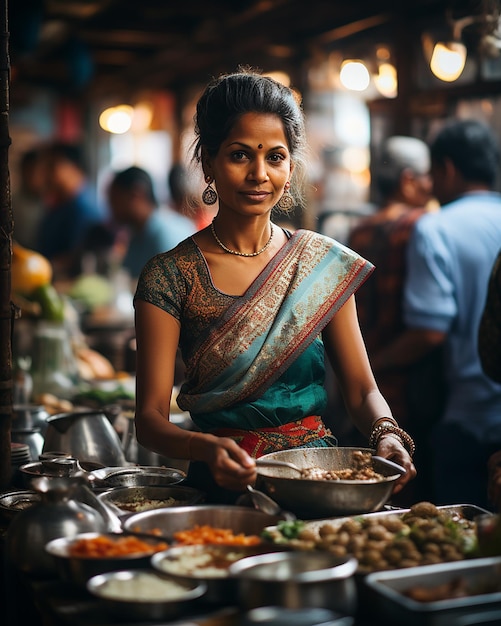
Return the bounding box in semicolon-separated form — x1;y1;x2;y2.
204;113;293;215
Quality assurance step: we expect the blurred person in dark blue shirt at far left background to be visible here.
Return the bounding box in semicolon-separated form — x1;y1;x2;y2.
36;142;106;280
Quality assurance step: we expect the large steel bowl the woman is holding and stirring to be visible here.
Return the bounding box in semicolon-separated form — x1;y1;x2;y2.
256;447;400;519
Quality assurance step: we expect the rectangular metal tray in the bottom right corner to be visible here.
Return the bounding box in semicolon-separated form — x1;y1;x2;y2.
364;557;501;626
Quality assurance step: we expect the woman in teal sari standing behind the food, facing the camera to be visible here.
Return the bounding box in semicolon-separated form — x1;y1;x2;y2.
134;71;416;502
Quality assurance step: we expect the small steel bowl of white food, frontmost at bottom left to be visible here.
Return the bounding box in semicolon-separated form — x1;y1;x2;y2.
86;569;206;622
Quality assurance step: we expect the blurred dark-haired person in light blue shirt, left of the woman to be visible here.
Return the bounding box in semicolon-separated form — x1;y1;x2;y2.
108;166;196;281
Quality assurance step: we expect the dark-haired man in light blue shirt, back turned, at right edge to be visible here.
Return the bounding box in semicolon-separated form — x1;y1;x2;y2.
370;120;501;508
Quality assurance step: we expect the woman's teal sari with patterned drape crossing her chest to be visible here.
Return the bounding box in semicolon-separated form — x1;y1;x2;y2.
177;230;373;431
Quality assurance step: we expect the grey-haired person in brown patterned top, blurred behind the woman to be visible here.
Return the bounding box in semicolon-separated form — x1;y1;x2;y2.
347;136;432;504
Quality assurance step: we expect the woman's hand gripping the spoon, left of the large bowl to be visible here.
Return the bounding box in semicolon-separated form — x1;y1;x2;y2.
195;435;256;491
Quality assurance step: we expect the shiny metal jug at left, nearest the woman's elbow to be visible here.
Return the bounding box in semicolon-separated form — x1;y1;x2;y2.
43;411;127;467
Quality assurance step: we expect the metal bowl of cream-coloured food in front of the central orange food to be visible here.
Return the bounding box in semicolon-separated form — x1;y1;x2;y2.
151;544;287;604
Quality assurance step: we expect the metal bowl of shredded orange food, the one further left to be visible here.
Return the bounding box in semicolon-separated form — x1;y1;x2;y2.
45;532;169;587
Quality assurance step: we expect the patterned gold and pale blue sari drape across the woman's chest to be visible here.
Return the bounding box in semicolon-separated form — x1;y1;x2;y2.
177;230;373;415
